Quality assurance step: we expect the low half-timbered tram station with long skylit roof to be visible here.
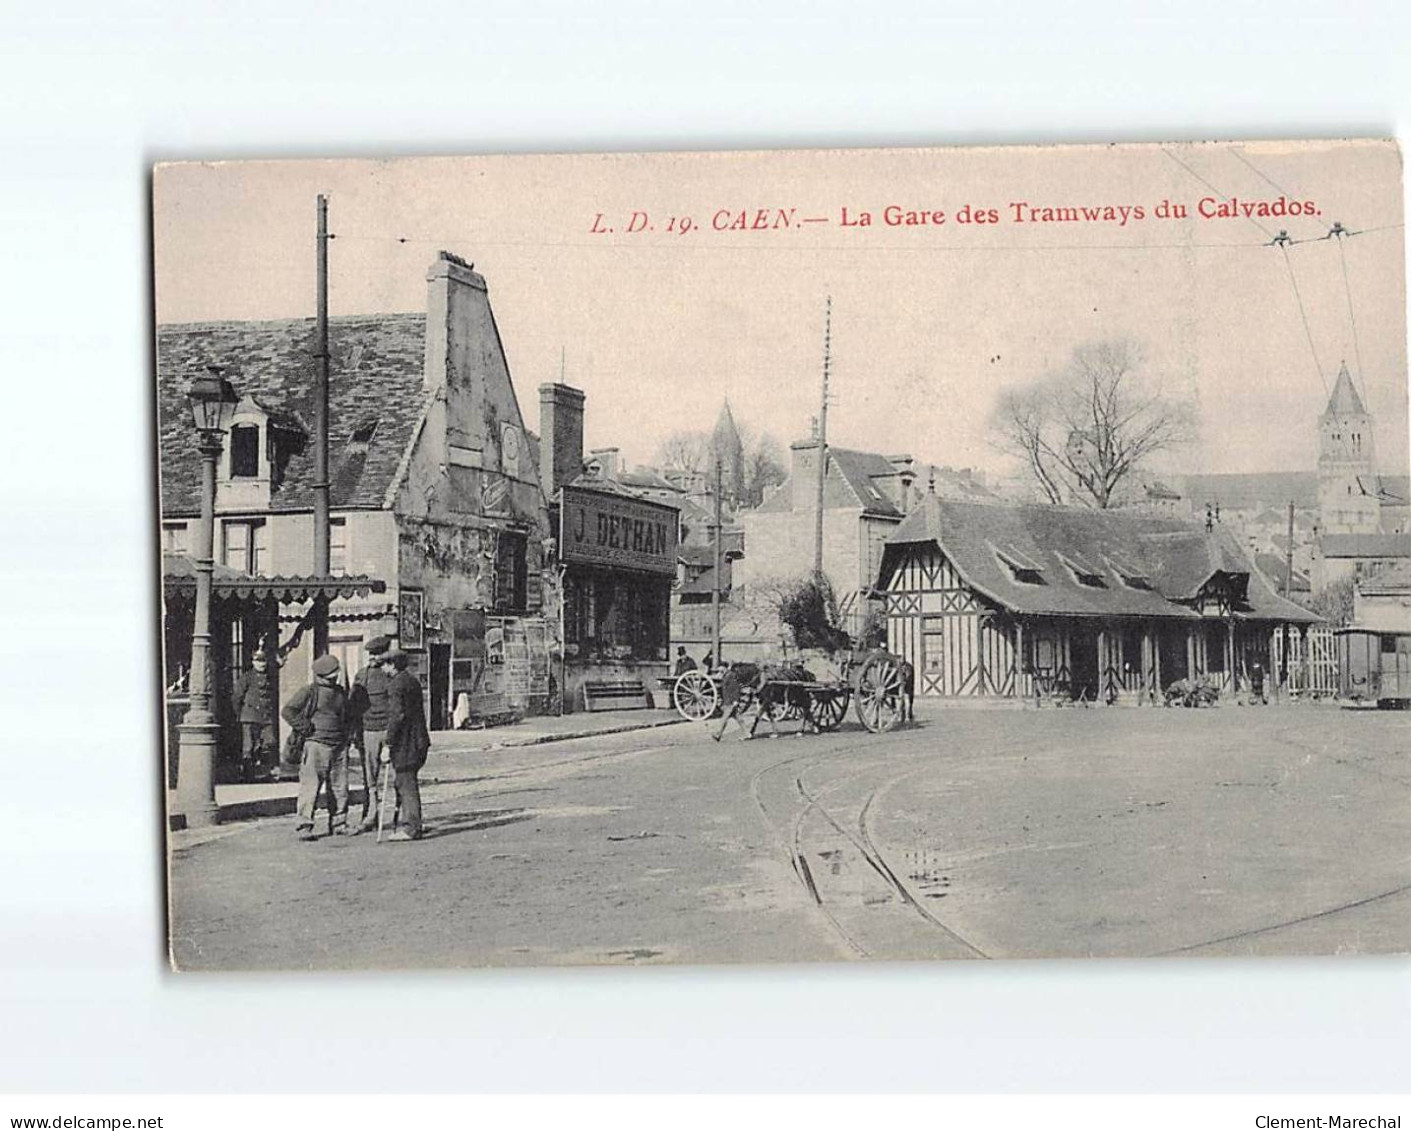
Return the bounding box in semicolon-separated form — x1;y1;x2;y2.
879;494;1318;702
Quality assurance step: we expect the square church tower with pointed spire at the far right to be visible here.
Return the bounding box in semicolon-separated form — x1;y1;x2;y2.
1318;362;1381;534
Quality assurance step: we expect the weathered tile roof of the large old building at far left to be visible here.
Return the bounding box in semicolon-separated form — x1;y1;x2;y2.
157;314;426;515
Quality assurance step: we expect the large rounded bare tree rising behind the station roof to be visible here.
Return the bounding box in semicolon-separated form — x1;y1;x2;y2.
991;340;1195;509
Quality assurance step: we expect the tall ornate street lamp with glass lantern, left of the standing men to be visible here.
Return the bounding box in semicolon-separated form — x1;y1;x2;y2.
175;368;240;828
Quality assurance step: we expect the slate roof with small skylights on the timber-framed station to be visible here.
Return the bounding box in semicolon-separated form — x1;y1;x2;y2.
880;494;1318;623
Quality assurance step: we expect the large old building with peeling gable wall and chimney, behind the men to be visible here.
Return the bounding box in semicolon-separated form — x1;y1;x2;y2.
157;252;557;728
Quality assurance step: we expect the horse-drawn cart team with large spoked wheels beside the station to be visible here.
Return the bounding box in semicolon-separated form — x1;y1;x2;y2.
669;652;912;733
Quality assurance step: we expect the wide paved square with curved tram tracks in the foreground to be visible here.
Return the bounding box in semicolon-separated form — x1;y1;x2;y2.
171;704;1411;969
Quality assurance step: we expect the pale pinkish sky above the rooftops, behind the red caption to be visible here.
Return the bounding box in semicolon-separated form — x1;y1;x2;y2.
152;141;1408;474
